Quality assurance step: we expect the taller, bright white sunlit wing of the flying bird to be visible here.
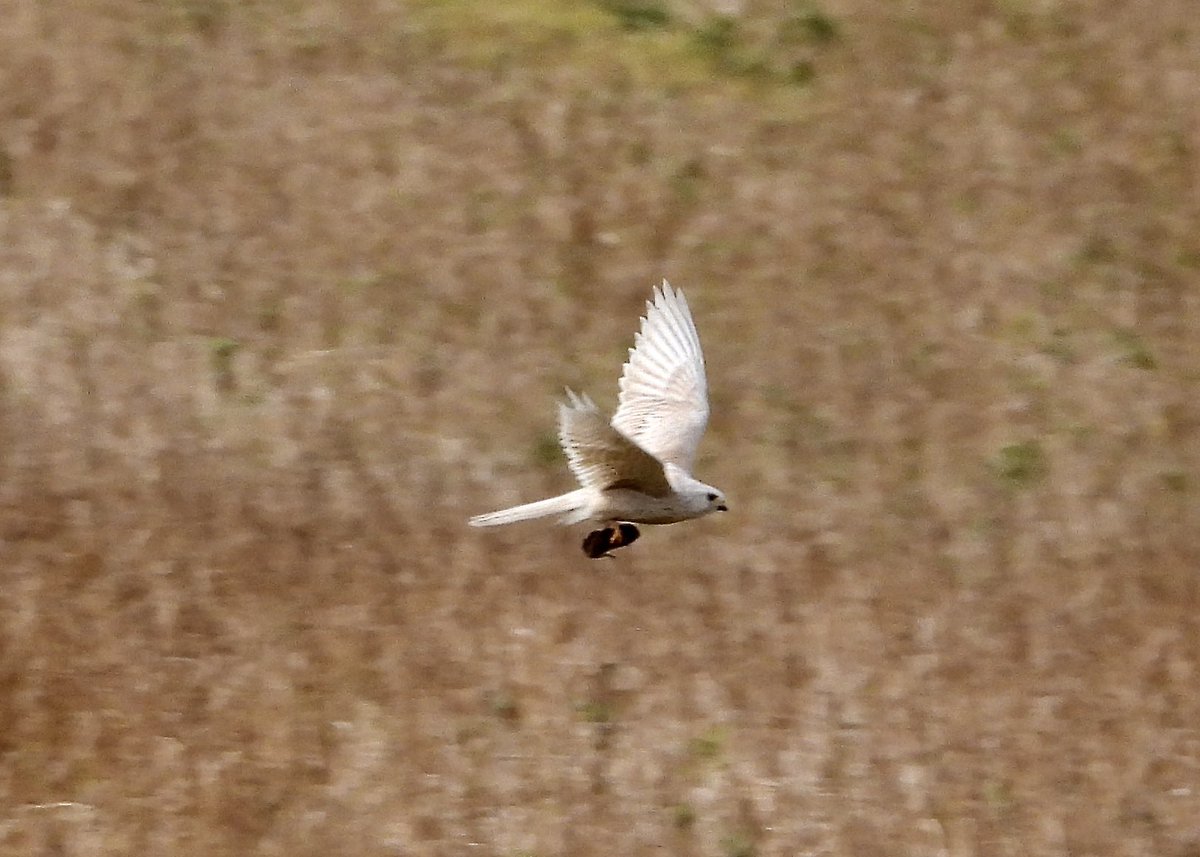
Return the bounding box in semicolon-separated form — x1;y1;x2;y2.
612;280;708;473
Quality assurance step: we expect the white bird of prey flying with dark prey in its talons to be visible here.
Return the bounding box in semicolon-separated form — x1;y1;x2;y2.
470;280;728;559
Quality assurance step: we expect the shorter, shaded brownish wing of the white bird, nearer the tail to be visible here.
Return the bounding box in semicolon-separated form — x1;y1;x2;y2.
558;390;671;497
